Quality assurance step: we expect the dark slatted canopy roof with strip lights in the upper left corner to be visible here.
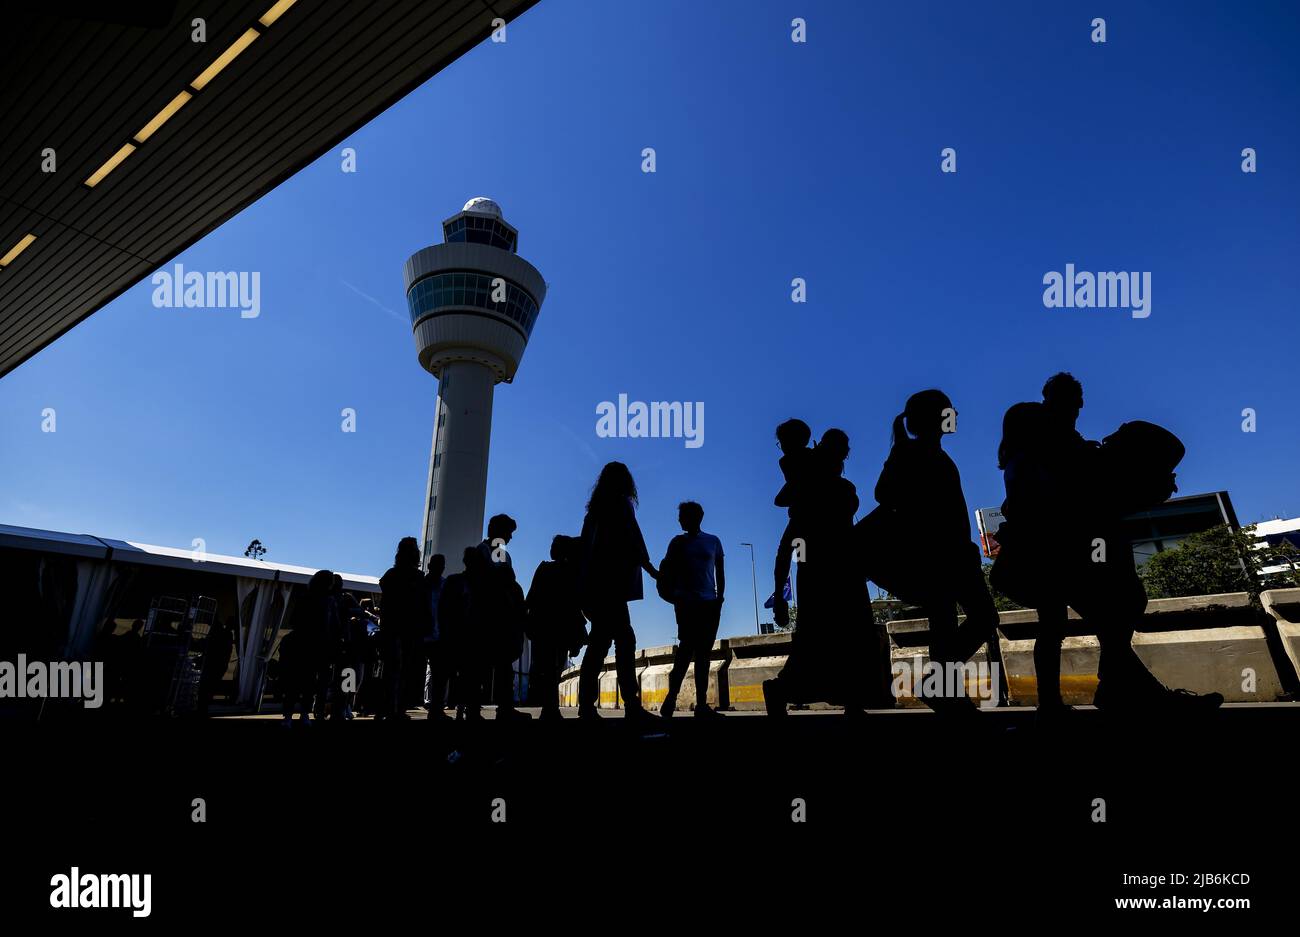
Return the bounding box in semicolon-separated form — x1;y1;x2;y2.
0;0;537;376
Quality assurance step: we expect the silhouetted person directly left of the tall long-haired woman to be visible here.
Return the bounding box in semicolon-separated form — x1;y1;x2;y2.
528;534;586;721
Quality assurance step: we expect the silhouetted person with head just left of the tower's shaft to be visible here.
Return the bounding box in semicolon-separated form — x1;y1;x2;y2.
376;537;429;721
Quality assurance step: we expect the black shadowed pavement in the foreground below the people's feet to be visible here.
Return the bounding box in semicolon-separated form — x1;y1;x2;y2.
0;704;1300;914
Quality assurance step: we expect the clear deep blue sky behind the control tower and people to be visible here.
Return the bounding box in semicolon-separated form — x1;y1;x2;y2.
0;0;1300;646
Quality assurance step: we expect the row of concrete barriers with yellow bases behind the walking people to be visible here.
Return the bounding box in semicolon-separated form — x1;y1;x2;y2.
560;589;1300;711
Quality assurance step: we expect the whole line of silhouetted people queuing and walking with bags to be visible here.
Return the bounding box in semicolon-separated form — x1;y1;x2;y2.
281;373;1222;723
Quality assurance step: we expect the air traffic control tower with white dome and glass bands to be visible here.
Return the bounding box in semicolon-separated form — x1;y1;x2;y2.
404;198;546;573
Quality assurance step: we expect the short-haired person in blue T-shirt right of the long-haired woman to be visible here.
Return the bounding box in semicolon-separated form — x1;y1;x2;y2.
659;502;727;717
